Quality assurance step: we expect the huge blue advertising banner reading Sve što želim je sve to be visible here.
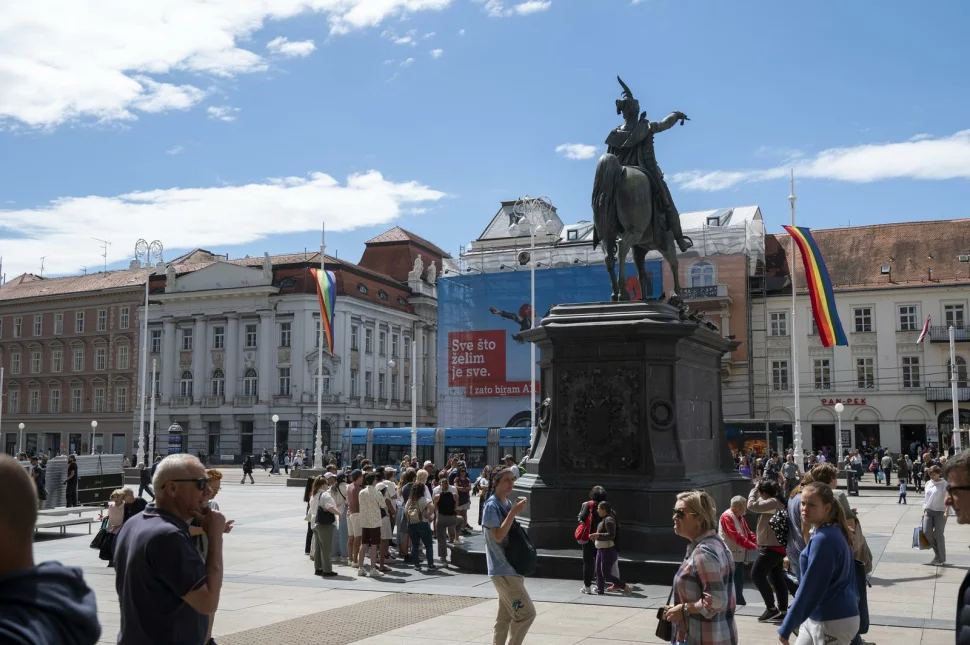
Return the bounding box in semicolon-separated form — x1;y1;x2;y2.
437;260;663;428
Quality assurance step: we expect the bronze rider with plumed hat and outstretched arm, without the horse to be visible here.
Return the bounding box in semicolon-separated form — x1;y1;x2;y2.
606;76;691;252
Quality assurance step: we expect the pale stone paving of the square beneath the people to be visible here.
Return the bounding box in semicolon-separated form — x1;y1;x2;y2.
35;471;956;645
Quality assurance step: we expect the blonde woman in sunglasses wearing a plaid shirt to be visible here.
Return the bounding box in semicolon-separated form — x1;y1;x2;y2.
665;490;738;645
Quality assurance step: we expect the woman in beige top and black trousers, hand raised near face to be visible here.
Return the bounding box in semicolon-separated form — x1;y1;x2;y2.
748;480;788;623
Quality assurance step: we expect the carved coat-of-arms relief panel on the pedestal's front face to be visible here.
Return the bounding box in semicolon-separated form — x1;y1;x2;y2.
556;368;640;472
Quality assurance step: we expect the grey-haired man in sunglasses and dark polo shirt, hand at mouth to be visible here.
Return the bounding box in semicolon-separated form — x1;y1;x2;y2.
115;454;226;645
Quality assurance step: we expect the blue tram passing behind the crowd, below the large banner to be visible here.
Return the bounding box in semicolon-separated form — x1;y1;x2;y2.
342;428;531;478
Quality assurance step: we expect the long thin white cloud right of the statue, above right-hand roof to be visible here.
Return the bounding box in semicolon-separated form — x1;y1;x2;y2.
671;130;970;191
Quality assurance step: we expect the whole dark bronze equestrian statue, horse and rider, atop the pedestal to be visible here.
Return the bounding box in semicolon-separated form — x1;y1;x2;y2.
592;76;693;301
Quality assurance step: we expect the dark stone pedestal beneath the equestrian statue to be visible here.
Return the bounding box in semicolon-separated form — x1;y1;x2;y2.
513;302;750;559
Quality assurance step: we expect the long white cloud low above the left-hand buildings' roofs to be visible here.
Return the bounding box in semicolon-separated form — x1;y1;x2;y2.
0;170;446;275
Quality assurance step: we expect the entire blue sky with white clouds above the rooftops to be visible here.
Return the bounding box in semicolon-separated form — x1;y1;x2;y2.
0;0;970;278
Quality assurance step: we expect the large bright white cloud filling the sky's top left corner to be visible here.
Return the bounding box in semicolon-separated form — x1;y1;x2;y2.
0;0;452;128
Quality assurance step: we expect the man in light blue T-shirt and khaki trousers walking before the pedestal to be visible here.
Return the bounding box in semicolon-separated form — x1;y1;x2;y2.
482;462;536;645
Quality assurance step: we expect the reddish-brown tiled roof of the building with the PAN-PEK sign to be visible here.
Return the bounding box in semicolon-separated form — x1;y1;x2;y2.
765;219;970;293
